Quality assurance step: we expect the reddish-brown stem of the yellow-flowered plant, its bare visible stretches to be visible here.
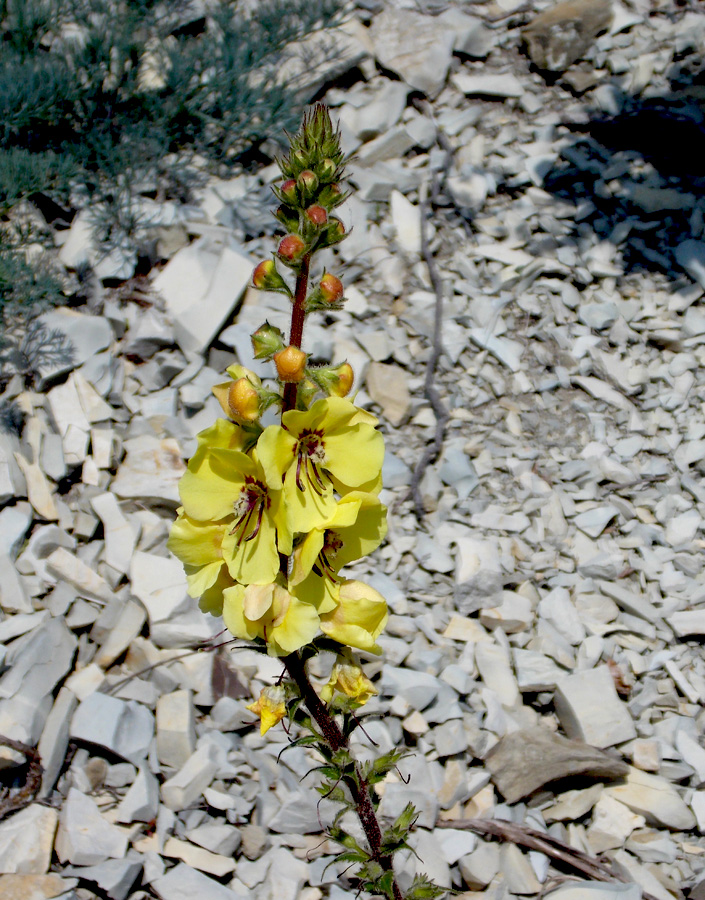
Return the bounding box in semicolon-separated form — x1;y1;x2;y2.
281;253;404;900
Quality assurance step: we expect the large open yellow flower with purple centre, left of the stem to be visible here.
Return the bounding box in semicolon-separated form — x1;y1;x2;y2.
179;446;291;584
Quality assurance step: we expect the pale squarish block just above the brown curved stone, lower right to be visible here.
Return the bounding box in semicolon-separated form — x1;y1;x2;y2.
554;666;636;748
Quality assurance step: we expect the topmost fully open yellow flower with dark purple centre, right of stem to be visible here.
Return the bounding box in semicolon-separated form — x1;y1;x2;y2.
257;397;384;555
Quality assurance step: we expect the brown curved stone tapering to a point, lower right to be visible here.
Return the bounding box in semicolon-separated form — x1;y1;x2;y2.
485;727;628;803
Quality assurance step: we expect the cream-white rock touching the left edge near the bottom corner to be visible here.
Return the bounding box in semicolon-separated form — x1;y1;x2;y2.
0;803;59;876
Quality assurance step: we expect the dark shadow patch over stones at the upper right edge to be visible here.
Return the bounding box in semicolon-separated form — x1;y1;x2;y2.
532;56;705;280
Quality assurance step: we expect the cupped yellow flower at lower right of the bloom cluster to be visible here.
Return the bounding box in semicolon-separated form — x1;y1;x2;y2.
320;581;388;653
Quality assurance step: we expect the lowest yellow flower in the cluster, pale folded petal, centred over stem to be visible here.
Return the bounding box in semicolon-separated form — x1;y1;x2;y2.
223;583;319;656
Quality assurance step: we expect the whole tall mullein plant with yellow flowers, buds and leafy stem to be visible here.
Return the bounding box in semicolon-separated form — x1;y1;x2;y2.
168;104;444;900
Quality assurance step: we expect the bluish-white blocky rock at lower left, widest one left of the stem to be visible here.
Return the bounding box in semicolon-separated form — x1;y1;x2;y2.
70;693;154;765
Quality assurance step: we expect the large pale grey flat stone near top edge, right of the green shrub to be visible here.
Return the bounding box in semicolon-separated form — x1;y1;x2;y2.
369;6;454;98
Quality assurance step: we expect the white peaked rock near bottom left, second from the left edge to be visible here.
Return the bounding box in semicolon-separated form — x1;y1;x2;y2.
54;788;127;866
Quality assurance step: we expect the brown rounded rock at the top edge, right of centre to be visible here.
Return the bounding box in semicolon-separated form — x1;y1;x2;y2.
523;0;613;72
